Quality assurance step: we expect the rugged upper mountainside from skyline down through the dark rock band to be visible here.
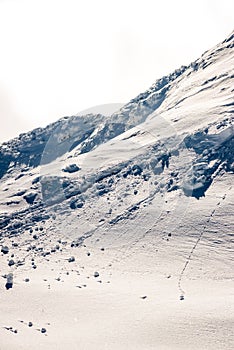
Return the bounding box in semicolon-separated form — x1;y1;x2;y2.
0;30;234;239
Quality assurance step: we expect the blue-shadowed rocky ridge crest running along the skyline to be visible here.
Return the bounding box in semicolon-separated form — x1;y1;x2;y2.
0;34;234;182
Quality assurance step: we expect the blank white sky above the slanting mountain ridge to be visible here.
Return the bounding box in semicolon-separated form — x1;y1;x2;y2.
0;0;234;142
